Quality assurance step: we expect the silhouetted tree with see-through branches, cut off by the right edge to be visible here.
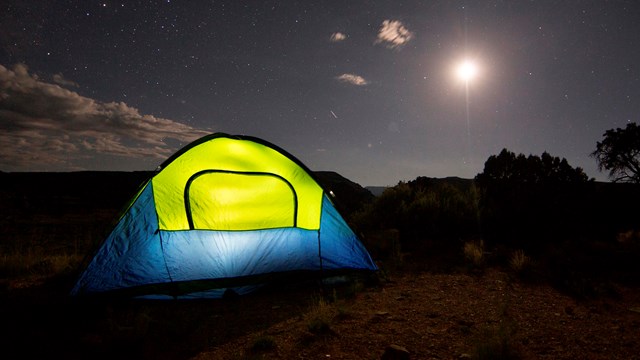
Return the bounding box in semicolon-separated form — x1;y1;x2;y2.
591;123;640;183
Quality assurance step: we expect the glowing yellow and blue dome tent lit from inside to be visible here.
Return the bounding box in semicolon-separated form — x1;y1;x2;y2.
72;133;376;298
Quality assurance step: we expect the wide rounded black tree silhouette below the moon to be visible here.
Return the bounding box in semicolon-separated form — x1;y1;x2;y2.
475;149;589;249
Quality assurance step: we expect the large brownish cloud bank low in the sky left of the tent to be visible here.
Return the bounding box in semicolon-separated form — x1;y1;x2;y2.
0;64;209;171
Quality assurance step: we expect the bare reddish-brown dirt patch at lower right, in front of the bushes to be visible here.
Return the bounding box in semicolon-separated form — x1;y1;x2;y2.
196;270;640;359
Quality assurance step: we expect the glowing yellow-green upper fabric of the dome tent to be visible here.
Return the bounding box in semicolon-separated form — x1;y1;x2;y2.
152;136;322;230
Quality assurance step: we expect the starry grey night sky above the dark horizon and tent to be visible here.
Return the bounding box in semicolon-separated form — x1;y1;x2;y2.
0;0;640;186
